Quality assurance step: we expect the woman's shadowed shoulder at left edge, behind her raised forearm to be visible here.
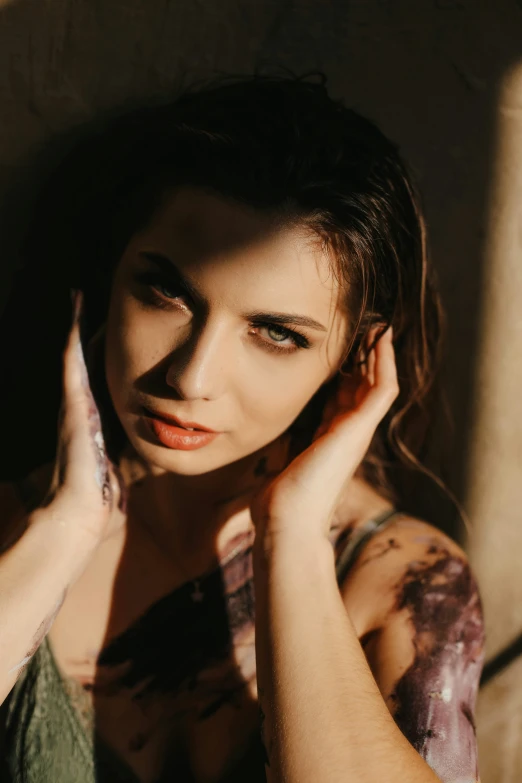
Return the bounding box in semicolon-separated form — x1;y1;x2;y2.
0;463;53;552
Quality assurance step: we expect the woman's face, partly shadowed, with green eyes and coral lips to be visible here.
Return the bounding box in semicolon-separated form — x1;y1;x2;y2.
106;188;346;475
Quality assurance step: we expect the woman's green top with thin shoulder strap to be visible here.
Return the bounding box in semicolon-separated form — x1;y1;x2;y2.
0;510;397;783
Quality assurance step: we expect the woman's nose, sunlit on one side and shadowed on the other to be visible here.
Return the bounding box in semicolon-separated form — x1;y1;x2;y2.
166;321;226;400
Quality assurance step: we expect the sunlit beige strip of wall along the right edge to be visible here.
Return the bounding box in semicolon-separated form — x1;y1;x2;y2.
467;63;522;783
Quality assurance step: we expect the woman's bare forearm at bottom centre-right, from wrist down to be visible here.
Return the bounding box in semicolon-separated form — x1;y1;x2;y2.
254;539;439;783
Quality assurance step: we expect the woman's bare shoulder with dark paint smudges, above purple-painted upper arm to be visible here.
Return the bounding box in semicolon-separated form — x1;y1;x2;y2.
341;514;478;635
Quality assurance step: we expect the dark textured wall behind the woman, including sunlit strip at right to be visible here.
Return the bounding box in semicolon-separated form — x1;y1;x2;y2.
0;0;522;783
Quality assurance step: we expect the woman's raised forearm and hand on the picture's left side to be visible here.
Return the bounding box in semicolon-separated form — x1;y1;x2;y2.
0;293;123;702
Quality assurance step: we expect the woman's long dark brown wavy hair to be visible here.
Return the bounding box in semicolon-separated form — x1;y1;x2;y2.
0;76;441;516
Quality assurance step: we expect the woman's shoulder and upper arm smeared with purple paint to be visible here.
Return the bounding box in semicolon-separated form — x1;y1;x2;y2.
342;516;484;781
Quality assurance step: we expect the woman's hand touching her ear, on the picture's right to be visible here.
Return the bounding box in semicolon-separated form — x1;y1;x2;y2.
250;327;399;542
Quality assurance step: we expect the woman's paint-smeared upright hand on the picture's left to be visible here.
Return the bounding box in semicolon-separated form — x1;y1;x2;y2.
43;291;124;543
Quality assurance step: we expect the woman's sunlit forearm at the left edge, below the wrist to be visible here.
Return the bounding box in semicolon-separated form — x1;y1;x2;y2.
0;508;95;703
